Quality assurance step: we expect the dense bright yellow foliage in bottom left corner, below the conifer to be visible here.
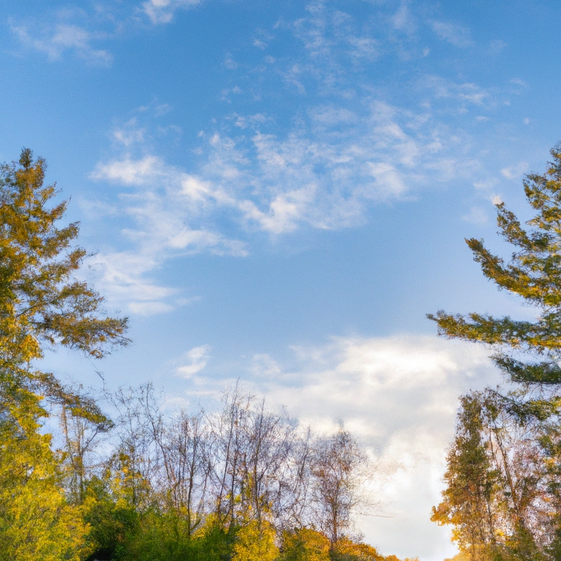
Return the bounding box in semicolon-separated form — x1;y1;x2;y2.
0;387;87;561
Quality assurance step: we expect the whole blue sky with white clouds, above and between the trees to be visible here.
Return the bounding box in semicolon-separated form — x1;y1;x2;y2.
0;0;561;561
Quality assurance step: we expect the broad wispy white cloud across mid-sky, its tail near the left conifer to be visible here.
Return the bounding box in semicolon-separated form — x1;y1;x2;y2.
85;88;488;314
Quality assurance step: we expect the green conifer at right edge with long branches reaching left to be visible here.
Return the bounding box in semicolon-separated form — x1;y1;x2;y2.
428;144;561;387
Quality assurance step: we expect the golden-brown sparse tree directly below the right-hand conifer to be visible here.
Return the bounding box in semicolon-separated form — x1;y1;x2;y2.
431;390;556;561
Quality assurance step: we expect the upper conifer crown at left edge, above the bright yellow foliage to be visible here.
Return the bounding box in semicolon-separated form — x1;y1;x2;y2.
0;149;128;380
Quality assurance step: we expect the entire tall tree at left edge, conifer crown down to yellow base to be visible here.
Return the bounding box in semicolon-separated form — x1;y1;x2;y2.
0;149;128;560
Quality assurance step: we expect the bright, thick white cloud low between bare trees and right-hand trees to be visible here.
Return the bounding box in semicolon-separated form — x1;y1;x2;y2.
173;335;499;560
